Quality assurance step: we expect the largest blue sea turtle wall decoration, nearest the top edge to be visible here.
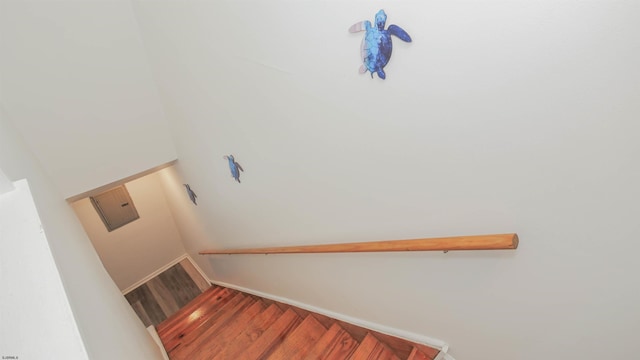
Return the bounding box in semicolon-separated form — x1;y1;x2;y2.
349;10;411;79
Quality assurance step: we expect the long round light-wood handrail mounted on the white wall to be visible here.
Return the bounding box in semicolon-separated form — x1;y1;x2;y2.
200;234;519;255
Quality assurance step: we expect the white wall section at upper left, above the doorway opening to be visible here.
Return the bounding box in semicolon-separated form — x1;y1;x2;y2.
0;0;176;198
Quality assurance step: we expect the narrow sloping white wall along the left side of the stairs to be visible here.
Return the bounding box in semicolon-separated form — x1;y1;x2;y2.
0;107;161;360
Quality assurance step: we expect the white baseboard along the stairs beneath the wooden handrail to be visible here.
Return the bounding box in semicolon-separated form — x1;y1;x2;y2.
209;279;448;352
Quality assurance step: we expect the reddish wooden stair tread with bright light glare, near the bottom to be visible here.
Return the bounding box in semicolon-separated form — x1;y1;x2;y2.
158;291;244;352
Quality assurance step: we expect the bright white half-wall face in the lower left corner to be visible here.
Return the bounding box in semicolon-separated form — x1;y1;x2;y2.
0;180;88;359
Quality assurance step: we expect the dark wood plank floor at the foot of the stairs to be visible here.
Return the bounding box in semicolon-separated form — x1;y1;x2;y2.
125;259;210;327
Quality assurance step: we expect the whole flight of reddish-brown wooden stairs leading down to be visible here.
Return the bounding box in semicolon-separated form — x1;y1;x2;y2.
157;285;438;360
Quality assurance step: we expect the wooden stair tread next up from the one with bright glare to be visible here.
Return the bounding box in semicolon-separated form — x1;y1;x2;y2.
189;299;266;359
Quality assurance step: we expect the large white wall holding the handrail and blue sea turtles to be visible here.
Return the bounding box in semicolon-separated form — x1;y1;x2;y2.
134;0;640;360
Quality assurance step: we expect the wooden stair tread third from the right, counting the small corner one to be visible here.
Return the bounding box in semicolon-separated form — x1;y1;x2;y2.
305;323;358;360
